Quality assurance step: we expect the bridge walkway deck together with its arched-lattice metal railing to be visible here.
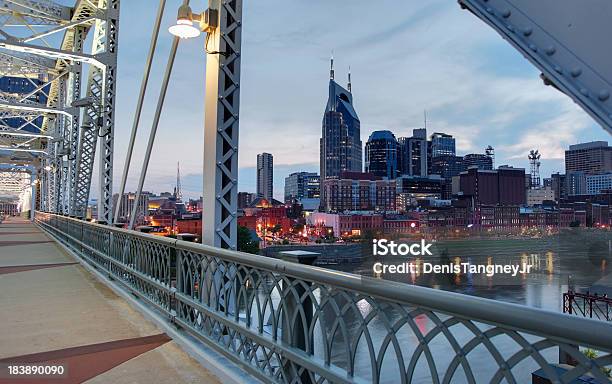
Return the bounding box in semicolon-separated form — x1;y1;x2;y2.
0;212;612;383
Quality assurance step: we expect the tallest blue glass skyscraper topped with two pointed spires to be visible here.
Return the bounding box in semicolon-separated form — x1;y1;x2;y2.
320;58;363;181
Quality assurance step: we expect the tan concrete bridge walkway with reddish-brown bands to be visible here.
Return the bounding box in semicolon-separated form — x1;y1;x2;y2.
0;218;220;383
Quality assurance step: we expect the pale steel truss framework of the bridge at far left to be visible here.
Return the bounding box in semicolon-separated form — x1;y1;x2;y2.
0;0;120;222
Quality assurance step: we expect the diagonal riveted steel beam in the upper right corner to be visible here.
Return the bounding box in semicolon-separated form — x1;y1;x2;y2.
459;0;612;134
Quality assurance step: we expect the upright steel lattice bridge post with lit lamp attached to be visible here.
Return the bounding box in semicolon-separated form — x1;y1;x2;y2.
169;0;242;250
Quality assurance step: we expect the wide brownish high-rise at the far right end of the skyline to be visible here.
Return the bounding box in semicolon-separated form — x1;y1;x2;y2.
565;141;612;175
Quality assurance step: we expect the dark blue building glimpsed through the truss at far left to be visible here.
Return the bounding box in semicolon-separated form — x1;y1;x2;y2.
0;76;51;132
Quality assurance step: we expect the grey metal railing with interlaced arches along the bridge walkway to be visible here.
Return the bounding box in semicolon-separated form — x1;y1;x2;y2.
36;213;612;383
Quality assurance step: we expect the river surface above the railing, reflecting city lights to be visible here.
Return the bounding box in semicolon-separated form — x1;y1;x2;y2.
329;230;612;311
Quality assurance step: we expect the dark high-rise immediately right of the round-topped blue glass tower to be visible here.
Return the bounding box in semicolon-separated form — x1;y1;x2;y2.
398;128;430;177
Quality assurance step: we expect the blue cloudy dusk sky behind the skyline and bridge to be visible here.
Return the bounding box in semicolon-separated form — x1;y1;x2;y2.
87;0;610;199
